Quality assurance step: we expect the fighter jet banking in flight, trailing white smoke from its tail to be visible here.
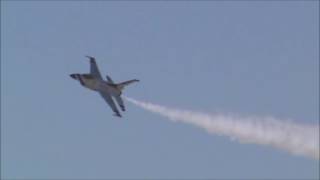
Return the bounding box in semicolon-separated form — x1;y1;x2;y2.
70;56;139;117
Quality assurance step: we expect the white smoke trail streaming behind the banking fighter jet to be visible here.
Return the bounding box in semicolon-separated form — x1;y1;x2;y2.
125;97;319;159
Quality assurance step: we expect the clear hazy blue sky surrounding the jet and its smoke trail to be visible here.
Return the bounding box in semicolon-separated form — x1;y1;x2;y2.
1;1;319;179
